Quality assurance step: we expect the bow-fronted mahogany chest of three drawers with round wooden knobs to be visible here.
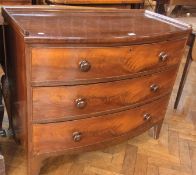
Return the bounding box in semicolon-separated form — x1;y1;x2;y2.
3;7;191;175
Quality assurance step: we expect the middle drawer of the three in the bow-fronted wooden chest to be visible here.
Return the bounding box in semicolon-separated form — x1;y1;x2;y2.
33;69;176;121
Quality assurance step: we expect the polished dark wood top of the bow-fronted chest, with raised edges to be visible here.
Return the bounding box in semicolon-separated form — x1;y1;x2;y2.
3;6;191;44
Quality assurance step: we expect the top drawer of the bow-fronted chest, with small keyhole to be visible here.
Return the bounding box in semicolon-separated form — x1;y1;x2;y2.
32;40;186;84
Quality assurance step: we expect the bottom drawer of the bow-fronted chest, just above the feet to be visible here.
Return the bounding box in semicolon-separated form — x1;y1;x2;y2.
33;96;169;154
